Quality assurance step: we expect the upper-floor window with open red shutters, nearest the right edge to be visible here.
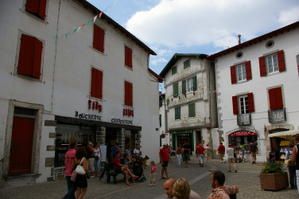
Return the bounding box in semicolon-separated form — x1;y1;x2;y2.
259;50;286;76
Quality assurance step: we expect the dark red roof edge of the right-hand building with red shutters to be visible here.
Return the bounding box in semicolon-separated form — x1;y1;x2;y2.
209;21;299;59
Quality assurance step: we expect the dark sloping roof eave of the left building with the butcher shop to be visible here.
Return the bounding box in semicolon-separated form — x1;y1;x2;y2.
76;0;157;55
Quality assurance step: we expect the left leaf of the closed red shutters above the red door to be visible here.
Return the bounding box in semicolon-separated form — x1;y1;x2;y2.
18;35;36;76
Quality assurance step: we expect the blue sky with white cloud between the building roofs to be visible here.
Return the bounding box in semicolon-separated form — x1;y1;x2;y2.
88;0;299;74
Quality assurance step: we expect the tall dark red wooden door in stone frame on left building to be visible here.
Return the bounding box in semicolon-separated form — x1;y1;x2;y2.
8;116;34;175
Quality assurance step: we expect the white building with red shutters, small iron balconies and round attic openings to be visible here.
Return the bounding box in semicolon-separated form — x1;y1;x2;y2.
210;22;299;161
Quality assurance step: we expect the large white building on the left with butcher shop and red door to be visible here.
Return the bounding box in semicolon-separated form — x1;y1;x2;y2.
0;0;159;185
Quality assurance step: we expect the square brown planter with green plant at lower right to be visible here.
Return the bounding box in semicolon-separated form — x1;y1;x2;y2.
260;162;289;191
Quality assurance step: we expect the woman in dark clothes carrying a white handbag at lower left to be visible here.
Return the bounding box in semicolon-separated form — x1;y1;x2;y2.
74;148;88;199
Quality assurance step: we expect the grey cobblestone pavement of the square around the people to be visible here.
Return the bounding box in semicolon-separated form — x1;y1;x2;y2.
0;160;299;199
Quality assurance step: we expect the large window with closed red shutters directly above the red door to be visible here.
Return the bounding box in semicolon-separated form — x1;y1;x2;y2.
17;34;43;79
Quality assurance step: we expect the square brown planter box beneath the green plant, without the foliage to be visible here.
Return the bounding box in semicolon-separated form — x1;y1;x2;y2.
260;172;289;191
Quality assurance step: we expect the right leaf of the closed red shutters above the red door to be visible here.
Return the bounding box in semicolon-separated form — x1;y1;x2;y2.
32;39;43;79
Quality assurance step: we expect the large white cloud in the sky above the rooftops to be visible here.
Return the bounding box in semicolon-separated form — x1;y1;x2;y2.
126;0;299;49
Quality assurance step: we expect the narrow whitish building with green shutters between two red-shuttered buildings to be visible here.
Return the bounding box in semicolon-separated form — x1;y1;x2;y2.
160;54;219;154
